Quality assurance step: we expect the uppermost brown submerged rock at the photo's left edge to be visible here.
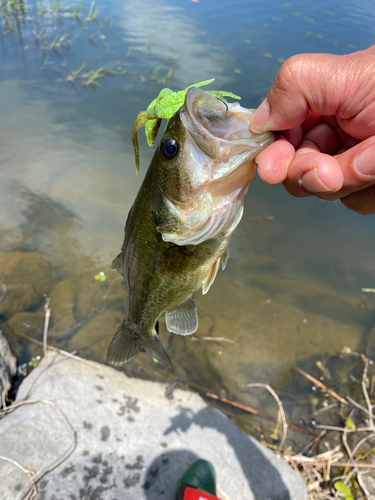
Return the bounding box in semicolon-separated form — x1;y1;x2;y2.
0;252;53;314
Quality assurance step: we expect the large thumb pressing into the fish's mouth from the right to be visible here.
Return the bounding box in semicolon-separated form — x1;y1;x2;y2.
249;46;375;134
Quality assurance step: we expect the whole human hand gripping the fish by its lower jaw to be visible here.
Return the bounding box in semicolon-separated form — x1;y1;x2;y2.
249;45;375;215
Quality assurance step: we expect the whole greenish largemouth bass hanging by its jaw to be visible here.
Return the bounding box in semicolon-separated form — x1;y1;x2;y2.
107;87;275;367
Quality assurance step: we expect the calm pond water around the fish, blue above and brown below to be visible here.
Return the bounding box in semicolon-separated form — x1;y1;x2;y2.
0;0;375;450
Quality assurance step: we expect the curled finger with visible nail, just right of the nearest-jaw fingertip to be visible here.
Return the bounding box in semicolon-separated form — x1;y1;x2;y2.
284;141;344;197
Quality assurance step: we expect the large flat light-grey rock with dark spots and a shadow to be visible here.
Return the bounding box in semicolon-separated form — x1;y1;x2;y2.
0;356;307;500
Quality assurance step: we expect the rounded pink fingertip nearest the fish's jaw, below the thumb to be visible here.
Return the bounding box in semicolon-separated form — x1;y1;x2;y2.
255;137;295;184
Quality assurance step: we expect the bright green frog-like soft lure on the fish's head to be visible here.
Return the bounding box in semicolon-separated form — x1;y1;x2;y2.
132;78;241;172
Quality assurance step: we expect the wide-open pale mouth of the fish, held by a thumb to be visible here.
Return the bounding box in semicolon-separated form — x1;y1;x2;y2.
182;87;275;161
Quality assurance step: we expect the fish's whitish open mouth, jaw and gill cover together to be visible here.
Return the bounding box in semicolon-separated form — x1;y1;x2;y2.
161;87;275;245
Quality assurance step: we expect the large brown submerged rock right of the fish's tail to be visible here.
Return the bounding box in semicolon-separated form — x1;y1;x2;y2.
181;274;362;394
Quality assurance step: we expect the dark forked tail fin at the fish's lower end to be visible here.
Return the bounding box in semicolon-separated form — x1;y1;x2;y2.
107;320;172;368
